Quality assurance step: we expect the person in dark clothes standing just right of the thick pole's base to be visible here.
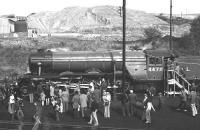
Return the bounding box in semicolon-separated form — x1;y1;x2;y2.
129;90;137;116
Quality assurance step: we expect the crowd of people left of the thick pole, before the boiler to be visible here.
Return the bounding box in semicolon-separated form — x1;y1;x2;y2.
0;79;111;130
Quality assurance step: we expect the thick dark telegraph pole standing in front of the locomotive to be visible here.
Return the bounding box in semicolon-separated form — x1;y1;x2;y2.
122;0;126;92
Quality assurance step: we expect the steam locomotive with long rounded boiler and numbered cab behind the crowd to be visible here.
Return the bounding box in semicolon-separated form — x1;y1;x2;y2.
22;50;174;92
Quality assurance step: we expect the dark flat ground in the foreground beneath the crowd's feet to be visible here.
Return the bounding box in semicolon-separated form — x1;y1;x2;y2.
0;97;200;130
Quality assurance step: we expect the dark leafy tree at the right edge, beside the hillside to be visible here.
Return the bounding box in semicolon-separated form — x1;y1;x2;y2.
190;16;200;55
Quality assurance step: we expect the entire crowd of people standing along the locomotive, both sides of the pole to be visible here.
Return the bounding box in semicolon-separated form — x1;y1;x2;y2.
0;76;200;130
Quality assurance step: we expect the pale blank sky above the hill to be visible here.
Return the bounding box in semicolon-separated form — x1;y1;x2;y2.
0;0;200;16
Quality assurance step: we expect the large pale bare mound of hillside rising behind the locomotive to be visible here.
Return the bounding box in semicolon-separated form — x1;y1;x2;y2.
28;6;165;32
